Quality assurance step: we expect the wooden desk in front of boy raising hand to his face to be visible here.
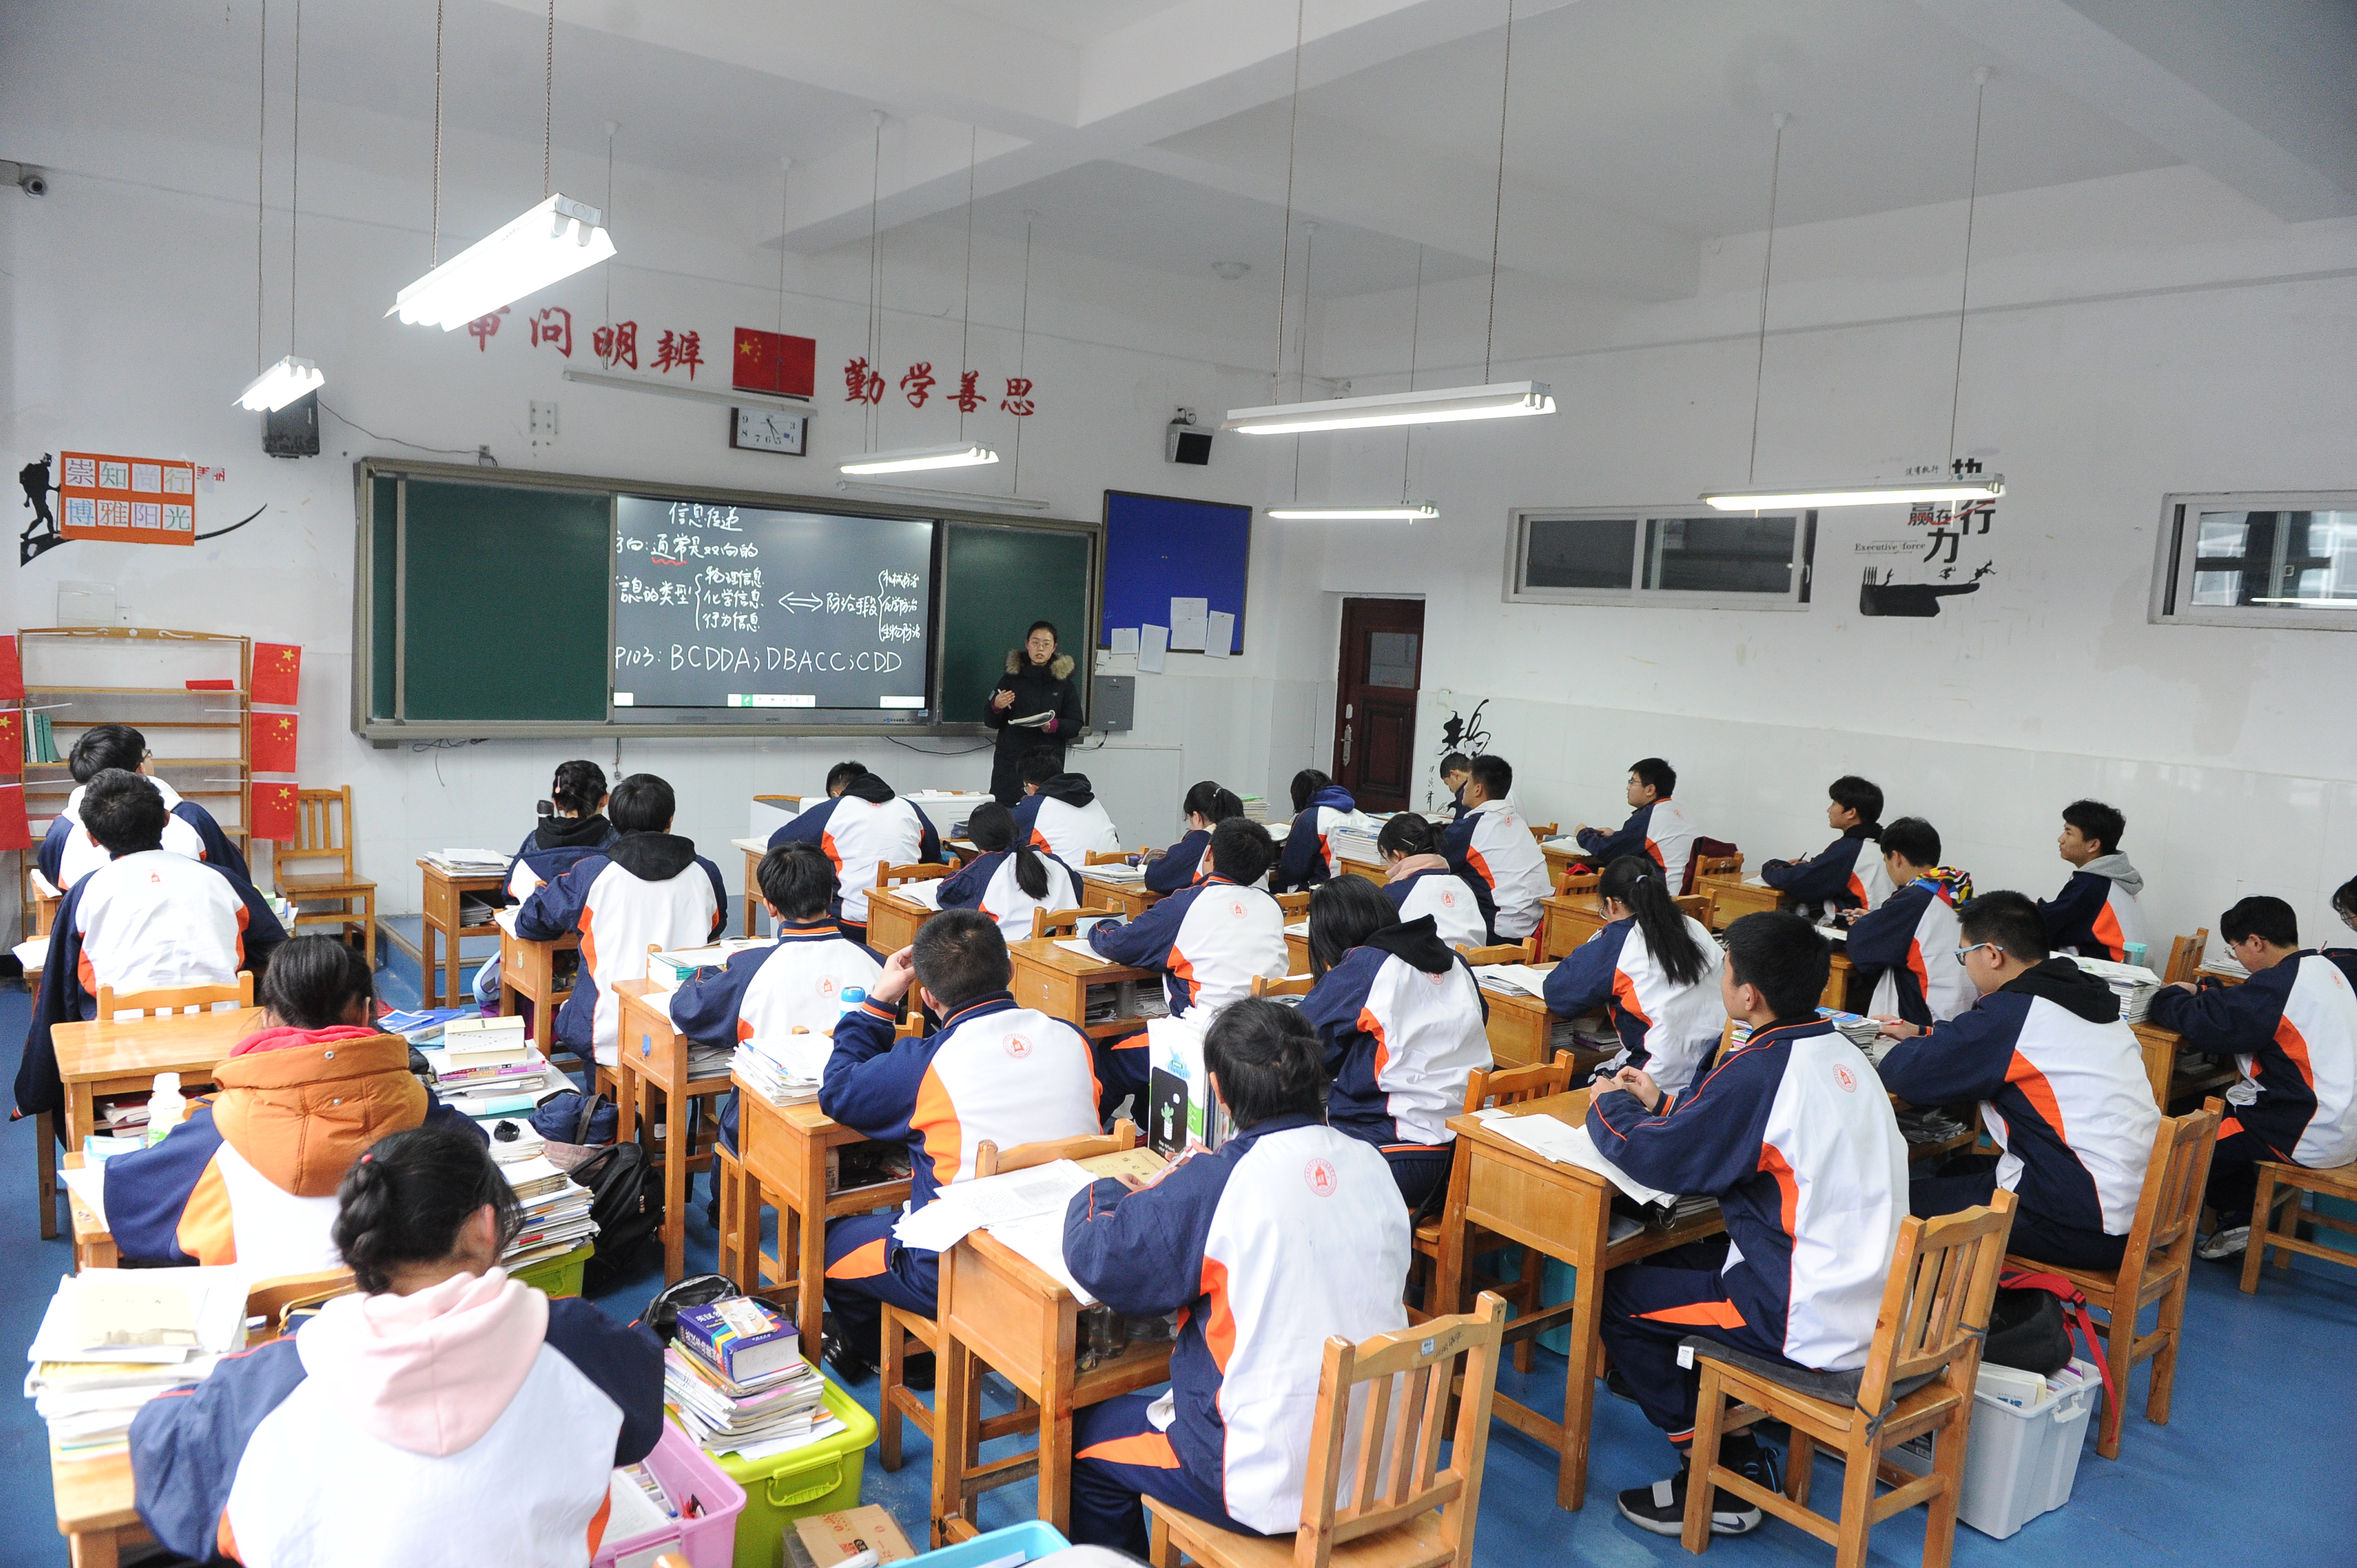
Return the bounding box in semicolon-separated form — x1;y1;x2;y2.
735;1085;910;1365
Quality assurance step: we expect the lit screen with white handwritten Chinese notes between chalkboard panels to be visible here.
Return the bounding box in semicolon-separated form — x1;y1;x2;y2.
613;495;936;721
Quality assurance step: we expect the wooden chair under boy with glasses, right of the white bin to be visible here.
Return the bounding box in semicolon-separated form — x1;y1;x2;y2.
2006;1099;2225;1459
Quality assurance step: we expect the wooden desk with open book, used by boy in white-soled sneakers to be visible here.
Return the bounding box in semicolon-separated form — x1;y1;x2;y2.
1430;1089;1725;1509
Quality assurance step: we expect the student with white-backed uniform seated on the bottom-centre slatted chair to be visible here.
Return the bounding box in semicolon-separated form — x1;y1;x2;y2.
1063;1000;1409;1561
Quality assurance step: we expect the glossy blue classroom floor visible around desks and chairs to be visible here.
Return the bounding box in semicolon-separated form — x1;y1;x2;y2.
0;957;2357;1568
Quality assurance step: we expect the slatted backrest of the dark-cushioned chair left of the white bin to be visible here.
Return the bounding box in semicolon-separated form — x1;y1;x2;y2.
1857;1188;2013;1415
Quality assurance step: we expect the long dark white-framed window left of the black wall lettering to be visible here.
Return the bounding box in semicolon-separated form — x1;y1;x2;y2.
1506;507;1817;611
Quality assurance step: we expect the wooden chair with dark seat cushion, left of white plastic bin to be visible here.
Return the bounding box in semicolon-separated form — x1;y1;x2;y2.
1685;1191;2013;1568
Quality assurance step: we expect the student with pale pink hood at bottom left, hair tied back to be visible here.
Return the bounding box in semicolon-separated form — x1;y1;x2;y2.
130;1127;662;1568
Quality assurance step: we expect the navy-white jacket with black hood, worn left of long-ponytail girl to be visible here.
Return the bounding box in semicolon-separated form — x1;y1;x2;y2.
1301;915;1490;1153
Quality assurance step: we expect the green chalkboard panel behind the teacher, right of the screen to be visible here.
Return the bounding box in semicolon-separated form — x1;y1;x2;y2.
940;523;1096;724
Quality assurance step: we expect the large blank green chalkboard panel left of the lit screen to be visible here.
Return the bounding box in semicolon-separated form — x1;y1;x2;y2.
401;479;613;721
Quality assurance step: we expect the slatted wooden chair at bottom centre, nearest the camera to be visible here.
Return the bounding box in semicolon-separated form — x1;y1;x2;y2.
1145;1292;1506;1568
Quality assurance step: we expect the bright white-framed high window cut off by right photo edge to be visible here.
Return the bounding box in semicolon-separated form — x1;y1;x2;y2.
2152;491;2357;632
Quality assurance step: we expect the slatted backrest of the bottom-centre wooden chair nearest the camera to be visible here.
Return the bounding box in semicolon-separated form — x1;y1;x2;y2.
1294;1290;1506;1568
